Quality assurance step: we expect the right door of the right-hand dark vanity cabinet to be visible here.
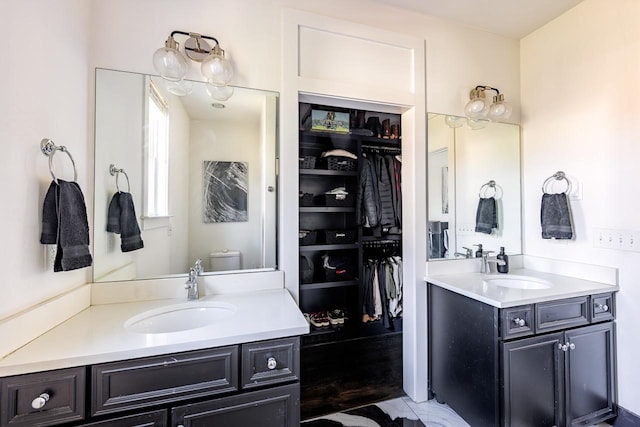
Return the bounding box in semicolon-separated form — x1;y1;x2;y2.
565;322;615;425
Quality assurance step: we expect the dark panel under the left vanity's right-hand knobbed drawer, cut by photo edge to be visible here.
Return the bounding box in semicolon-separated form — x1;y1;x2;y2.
171;384;300;427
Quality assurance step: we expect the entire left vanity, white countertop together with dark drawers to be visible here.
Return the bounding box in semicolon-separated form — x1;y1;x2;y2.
0;289;308;427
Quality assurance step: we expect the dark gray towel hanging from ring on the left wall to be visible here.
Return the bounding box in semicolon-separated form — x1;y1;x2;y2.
40;179;93;272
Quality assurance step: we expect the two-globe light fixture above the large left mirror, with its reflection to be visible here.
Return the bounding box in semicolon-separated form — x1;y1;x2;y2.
153;31;233;101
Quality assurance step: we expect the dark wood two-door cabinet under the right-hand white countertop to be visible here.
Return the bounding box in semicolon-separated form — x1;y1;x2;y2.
429;284;616;427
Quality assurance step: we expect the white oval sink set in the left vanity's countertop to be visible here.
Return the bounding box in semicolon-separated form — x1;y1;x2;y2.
124;301;236;334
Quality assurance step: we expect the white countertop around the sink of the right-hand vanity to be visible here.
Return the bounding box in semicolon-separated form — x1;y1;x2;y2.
425;268;619;308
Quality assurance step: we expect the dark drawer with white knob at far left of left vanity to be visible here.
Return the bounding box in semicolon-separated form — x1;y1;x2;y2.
0;367;85;427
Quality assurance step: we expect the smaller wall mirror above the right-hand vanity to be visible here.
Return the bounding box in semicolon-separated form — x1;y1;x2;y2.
427;113;522;261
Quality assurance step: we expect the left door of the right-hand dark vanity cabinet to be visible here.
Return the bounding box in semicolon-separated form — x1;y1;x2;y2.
502;333;564;427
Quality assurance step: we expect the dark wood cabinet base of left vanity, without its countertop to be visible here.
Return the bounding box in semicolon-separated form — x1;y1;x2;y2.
0;337;300;427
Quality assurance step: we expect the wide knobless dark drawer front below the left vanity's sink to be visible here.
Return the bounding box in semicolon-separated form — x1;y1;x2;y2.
91;346;238;415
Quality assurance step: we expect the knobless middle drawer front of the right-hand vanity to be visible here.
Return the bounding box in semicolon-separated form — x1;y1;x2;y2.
535;296;589;333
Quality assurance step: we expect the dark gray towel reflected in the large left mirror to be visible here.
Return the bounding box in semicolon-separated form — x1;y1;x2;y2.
107;191;144;252
